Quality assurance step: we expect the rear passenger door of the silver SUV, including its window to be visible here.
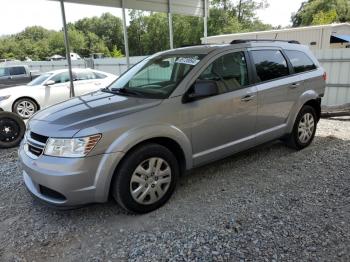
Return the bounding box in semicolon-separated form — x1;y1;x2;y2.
249;48;301;140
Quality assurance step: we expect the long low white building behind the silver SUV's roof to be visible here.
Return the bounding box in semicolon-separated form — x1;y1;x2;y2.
201;23;350;49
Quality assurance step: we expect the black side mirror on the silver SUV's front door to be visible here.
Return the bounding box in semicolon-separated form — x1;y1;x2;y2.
183;80;219;103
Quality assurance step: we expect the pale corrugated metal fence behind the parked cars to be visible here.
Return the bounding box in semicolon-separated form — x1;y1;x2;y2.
2;48;350;106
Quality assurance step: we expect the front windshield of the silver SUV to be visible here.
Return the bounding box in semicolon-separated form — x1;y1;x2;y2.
108;54;204;98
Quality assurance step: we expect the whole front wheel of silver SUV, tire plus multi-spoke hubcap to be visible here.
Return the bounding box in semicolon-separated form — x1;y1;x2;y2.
112;143;179;214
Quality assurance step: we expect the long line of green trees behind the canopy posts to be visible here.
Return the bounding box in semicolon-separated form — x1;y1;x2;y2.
0;0;274;60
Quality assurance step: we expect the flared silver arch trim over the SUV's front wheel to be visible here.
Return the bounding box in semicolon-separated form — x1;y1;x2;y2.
107;124;193;169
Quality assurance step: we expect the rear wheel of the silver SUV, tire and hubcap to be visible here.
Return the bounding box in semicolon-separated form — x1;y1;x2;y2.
286;105;317;150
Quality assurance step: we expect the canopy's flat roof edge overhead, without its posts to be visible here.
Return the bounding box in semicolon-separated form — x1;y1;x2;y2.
50;0;207;16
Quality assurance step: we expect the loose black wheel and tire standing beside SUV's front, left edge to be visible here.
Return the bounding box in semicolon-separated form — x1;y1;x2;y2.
0;112;26;148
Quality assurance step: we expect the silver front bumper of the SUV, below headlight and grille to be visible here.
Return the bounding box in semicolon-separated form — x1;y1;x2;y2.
18;144;124;207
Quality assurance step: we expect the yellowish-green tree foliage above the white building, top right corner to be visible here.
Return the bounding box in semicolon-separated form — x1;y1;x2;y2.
292;0;350;26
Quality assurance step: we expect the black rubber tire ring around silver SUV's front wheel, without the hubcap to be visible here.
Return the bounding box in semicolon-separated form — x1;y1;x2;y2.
112;144;179;213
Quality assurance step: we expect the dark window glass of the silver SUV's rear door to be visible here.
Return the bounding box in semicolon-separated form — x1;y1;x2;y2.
251;50;289;82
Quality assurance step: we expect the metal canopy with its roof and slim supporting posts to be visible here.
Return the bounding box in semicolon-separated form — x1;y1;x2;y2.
49;0;208;97
